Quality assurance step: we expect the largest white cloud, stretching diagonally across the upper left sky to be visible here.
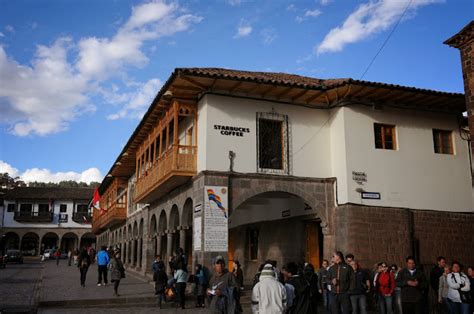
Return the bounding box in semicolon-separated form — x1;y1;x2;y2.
0;0;202;136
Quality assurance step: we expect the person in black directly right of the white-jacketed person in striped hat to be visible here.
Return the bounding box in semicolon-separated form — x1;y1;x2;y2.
284;262;316;314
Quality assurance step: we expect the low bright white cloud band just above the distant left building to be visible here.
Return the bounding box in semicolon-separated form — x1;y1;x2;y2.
0;160;102;183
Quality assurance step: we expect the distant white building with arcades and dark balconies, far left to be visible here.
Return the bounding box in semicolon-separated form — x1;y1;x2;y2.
0;187;95;256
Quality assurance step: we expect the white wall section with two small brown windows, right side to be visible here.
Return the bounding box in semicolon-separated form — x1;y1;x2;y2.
333;106;473;212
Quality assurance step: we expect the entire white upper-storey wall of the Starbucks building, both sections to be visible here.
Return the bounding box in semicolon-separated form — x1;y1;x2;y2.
197;94;474;212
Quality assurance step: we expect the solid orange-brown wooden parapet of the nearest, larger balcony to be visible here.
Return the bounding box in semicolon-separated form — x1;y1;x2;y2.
134;144;197;203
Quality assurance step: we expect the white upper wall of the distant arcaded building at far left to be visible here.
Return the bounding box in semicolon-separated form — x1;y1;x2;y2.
3;200;91;229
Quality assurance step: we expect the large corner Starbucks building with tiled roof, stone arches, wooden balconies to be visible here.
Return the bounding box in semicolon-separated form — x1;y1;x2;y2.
93;68;474;278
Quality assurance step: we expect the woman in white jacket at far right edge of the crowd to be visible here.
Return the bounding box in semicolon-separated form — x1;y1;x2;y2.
447;262;471;314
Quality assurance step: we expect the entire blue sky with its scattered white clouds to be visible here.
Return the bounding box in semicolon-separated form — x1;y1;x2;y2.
0;0;474;181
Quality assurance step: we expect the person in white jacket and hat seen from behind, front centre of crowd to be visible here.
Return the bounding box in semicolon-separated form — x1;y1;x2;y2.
252;264;286;314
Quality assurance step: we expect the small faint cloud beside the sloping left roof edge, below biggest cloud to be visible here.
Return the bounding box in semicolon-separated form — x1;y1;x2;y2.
107;78;162;120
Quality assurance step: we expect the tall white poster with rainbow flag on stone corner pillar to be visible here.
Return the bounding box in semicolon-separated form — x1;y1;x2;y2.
204;186;229;252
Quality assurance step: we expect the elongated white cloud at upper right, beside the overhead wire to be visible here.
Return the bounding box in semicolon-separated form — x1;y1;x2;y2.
315;0;442;54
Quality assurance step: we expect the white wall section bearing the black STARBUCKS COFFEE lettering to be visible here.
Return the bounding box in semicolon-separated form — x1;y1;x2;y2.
198;95;331;178
